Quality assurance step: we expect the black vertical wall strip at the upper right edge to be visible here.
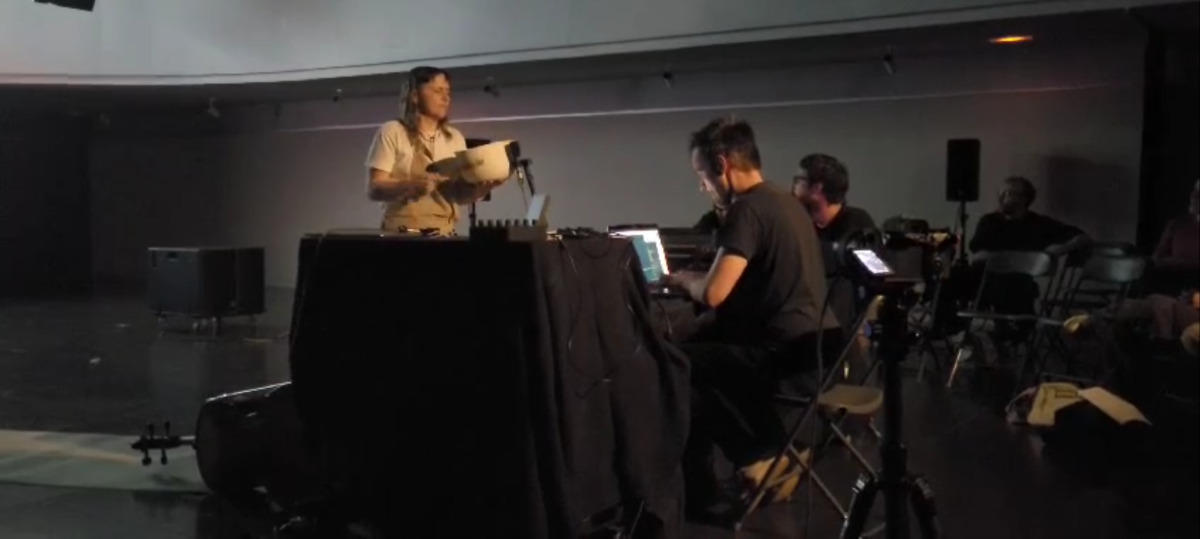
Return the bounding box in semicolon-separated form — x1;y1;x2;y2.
1138;5;1200;250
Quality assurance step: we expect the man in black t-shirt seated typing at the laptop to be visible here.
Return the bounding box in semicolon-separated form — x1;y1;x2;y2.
668;119;842;516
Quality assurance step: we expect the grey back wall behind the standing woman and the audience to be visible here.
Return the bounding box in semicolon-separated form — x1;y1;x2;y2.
92;43;1141;290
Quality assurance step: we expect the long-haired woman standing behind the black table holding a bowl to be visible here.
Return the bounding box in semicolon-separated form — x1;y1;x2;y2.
366;66;498;235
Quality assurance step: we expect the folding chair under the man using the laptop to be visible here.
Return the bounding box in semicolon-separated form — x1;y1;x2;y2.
734;297;883;529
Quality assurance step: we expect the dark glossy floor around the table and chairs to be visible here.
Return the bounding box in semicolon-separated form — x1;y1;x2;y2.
0;291;1198;539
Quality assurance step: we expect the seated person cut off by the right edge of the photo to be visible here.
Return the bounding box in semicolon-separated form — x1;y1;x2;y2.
1152;181;1200;293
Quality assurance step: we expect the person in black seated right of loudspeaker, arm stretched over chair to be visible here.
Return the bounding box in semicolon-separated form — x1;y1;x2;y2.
967;176;1091;313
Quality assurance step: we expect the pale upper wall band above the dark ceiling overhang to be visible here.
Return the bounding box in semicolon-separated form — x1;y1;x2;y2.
0;0;1170;84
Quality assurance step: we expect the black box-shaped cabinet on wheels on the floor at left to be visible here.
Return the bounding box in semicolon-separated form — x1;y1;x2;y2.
146;247;266;318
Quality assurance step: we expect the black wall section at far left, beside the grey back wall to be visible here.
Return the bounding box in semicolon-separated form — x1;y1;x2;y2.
0;112;91;298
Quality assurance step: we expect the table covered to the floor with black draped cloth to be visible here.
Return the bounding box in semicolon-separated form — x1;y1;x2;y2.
290;234;688;539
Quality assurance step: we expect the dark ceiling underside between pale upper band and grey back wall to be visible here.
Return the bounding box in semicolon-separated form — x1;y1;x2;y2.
0;5;1171;115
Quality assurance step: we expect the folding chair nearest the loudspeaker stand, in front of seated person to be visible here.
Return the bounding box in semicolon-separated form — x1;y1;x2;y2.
946;251;1062;388
